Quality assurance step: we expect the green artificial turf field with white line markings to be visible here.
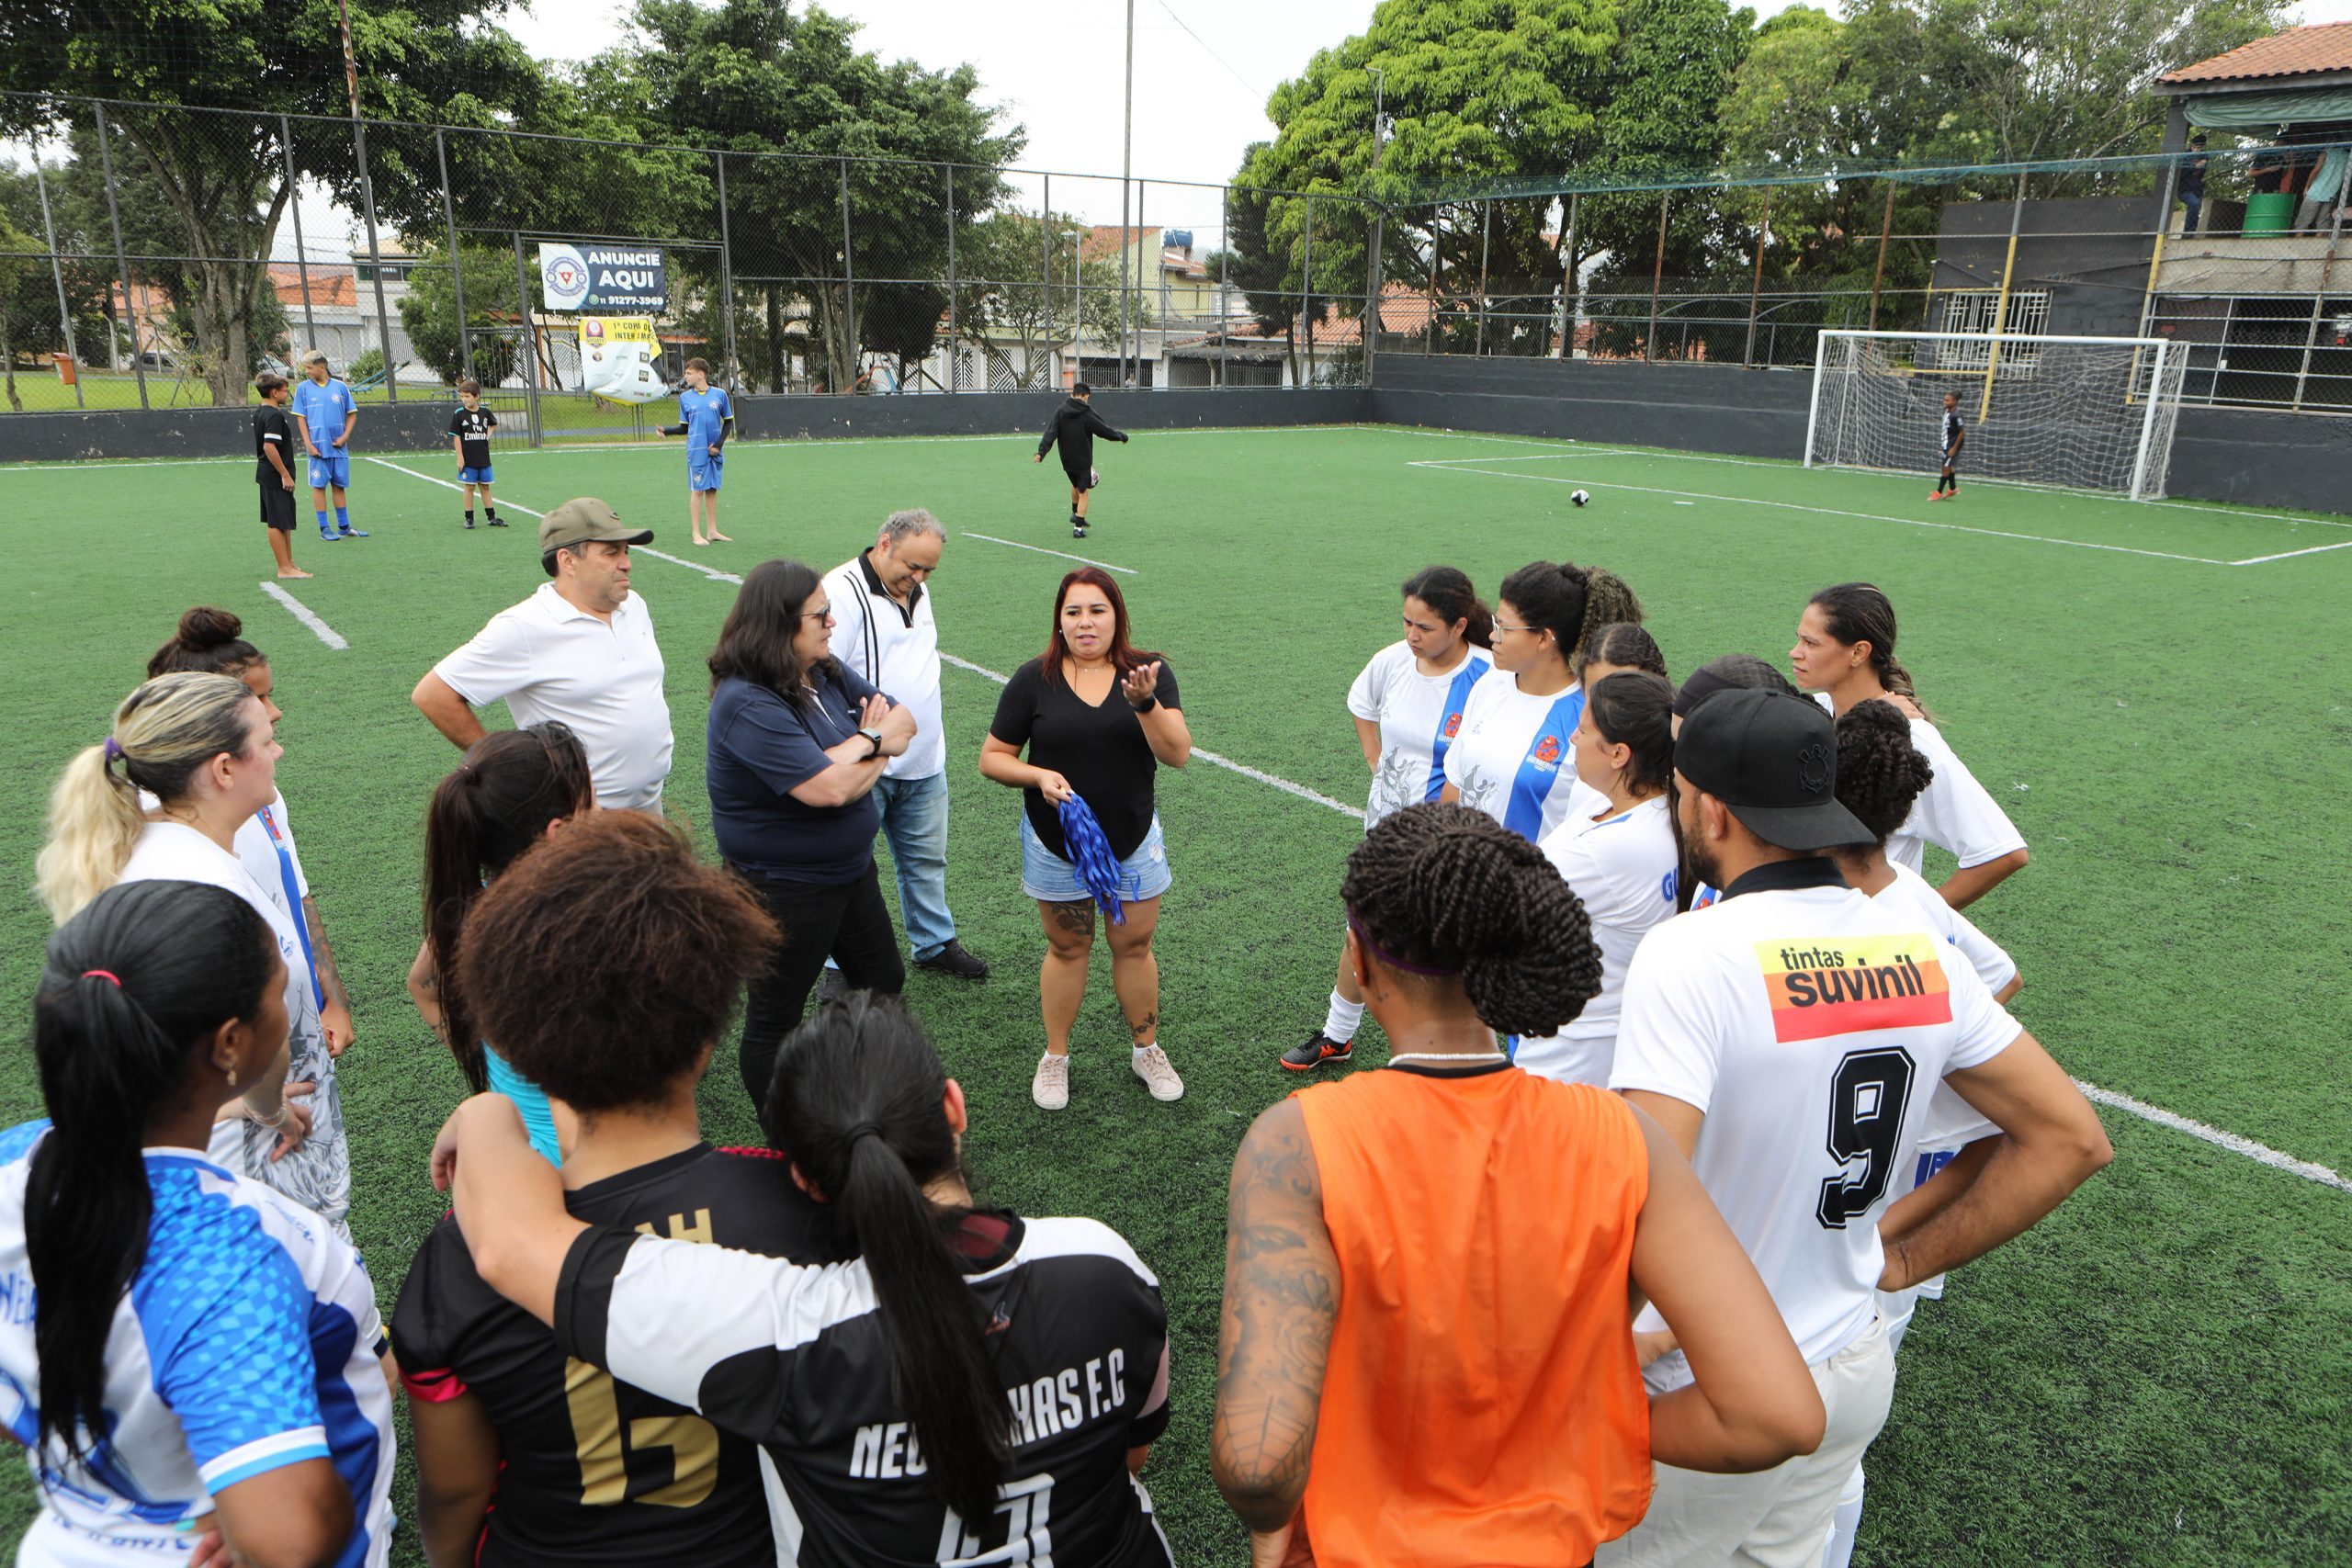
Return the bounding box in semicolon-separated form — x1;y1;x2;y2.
0;428;2352;1565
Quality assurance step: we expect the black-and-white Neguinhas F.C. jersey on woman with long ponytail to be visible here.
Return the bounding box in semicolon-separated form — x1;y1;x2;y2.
555;1211;1173;1568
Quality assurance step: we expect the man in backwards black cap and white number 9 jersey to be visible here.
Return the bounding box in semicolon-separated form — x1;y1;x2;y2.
1595;691;2112;1568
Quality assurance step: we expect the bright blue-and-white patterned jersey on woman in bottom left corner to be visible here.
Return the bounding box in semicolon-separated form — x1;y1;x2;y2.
0;1122;393;1568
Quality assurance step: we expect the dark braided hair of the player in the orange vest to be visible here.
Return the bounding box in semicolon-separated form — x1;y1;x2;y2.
1340;804;1601;1034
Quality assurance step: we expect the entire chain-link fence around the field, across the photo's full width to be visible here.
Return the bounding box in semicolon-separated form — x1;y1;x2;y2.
0;94;2352;425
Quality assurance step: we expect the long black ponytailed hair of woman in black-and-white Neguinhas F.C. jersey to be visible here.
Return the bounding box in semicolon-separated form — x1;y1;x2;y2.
762;992;1012;1518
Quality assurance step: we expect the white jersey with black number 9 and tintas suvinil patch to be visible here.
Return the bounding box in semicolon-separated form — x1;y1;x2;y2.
1609;861;2018;1382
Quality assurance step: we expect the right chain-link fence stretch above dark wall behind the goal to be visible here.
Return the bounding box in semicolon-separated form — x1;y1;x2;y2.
1378;141;2352;409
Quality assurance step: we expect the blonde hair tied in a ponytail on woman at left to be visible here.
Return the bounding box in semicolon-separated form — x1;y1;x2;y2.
35;670;256;924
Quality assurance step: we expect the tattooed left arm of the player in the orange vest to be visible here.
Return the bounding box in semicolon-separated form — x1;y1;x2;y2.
1209;1100;1340;1530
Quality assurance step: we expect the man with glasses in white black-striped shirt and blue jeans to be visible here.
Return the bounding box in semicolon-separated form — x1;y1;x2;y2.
826;508;988;989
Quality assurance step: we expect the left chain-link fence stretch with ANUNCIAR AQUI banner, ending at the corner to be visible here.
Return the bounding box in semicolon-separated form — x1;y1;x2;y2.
0;94;1374;432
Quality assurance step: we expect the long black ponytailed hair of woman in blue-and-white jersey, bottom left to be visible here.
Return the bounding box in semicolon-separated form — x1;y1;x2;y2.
24;882;277;1455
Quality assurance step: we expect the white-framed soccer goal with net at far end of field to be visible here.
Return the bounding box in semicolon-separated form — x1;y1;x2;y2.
1804;329;2188;501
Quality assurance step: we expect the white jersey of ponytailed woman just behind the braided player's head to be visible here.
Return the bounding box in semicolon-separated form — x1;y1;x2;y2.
1512;795;1675;1086
